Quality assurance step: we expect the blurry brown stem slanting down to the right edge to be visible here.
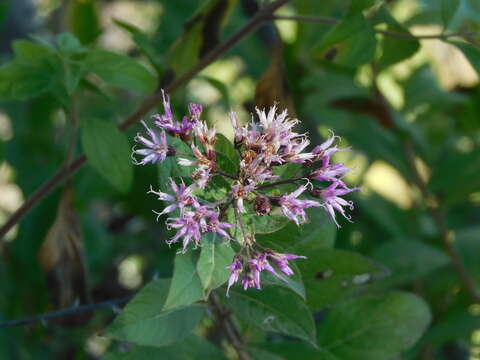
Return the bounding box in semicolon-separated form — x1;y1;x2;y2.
404;140;480;303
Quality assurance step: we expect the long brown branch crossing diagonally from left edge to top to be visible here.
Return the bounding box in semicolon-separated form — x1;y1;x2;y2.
0;0;289;241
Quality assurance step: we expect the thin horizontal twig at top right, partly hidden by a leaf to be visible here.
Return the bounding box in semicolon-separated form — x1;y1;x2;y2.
272;15;480;40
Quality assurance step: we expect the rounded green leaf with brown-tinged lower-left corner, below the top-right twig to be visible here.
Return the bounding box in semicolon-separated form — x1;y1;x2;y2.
313;14;377;68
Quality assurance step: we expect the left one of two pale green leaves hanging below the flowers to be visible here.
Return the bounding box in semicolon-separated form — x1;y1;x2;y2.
164;251;203;310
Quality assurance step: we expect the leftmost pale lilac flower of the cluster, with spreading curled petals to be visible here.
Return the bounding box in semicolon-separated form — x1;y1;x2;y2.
132;121;169;165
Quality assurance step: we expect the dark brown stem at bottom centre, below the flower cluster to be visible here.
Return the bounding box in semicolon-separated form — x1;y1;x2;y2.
208;293;251;360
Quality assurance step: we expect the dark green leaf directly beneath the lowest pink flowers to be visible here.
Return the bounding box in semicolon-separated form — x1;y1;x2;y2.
227;286;316;345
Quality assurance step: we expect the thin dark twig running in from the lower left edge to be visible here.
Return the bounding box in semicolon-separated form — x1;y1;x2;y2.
0;295;133;328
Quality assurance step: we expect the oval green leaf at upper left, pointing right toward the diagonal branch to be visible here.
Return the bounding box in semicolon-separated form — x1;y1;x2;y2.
85;49;157;93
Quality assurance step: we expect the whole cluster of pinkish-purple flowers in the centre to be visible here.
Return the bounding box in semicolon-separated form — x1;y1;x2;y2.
132;93;359;294
